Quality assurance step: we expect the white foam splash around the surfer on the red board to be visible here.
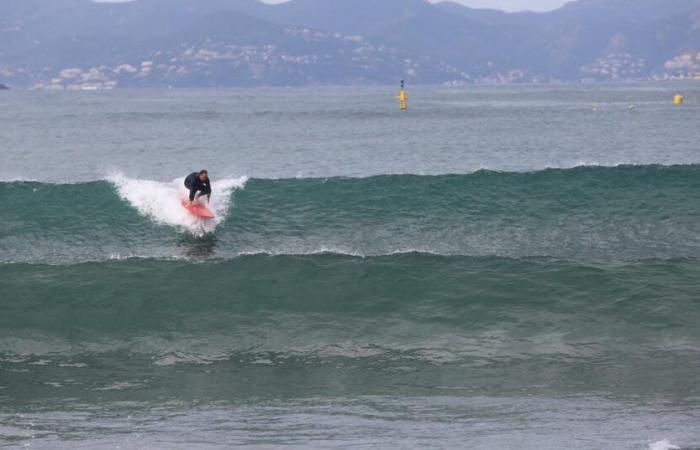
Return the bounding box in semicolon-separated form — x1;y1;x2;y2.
108;174;248;236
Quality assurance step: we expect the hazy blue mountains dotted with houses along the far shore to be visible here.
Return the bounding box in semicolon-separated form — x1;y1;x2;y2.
0;0;700;89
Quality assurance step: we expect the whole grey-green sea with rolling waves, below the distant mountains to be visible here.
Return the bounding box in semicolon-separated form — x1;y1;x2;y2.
0;82;700;450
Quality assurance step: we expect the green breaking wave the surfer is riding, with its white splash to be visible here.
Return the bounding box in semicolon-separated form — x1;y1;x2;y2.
0;165;700;264
